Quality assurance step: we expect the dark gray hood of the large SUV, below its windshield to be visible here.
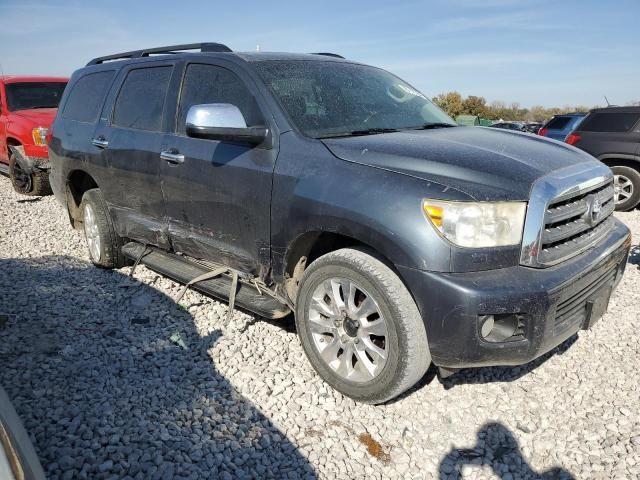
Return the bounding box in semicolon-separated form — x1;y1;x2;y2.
322;127;597;200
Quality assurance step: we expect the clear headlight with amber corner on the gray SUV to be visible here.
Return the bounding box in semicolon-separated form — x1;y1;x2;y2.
422;200;527;248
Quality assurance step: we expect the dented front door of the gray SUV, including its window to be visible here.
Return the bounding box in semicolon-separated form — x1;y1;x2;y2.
161;63;277;275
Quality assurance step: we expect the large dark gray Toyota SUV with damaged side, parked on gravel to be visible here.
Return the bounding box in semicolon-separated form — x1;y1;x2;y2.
50;43;630;403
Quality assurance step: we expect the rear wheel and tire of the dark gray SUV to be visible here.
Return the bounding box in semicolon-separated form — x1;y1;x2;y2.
80;188;127;268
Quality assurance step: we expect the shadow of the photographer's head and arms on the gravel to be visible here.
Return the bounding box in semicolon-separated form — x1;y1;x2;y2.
439;423;575;480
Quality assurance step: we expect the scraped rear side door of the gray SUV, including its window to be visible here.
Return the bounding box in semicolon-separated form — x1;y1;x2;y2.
93;62;175;248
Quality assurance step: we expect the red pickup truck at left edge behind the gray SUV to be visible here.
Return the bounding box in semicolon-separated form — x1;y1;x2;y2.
0;76;68;195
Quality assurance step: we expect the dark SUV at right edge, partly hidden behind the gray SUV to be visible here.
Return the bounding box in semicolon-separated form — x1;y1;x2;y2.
565;107;640;211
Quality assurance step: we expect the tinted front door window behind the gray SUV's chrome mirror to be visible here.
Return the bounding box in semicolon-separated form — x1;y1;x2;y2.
176;64;264;133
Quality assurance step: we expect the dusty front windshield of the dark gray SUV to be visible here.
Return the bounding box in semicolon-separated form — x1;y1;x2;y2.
256;60;456;138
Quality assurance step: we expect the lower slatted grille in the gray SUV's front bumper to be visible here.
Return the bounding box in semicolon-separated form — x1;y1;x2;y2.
554;265;618;335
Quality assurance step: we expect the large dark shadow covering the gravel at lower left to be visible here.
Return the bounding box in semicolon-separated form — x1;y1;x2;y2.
0;256;316;480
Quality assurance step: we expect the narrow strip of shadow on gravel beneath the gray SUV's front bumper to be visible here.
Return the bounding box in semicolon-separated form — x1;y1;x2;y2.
440;334;578;389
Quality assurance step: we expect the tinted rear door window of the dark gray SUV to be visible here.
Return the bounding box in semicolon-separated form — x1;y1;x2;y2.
113;66;173;131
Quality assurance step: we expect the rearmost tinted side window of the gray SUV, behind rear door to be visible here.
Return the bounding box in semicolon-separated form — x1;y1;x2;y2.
61;70;115;122
